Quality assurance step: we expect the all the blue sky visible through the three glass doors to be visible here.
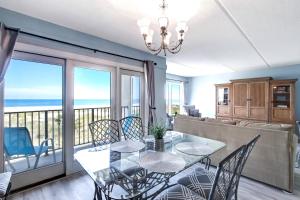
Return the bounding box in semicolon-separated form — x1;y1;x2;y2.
5;59;139;100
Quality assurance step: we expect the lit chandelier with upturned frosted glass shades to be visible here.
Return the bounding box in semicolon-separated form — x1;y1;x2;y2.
137;0;188;56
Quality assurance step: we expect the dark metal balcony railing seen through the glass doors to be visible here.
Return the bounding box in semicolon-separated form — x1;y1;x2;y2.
4;106;140;150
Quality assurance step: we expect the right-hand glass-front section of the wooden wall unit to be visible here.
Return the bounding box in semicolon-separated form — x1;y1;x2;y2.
270;79;296;123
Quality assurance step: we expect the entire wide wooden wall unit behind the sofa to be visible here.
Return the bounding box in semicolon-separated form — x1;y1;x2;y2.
216;77;296;123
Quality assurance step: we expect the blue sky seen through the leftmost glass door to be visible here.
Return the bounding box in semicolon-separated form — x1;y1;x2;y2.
4;59;62;99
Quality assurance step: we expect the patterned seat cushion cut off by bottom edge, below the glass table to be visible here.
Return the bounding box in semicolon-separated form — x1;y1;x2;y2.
155;185;204;200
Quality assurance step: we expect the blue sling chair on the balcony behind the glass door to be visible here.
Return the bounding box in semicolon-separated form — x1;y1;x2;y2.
4;127;56;171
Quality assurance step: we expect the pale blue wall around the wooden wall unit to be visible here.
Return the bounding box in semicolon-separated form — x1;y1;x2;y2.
187;64;300;120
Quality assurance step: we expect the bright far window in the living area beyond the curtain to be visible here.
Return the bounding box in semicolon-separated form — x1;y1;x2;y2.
166;80;184;115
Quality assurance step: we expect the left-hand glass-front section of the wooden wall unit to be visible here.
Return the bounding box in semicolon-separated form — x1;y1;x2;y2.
215;84;232;118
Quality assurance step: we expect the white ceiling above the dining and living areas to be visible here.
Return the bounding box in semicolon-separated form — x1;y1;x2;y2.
0;0;300;76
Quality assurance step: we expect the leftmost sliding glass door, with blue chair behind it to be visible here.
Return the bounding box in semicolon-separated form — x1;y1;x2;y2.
3;53;65;188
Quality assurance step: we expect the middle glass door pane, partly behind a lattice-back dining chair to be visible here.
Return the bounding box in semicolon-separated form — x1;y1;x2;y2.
73;63;114;152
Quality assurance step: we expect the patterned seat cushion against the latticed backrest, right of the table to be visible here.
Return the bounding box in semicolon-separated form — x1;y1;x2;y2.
177;168;215;199
